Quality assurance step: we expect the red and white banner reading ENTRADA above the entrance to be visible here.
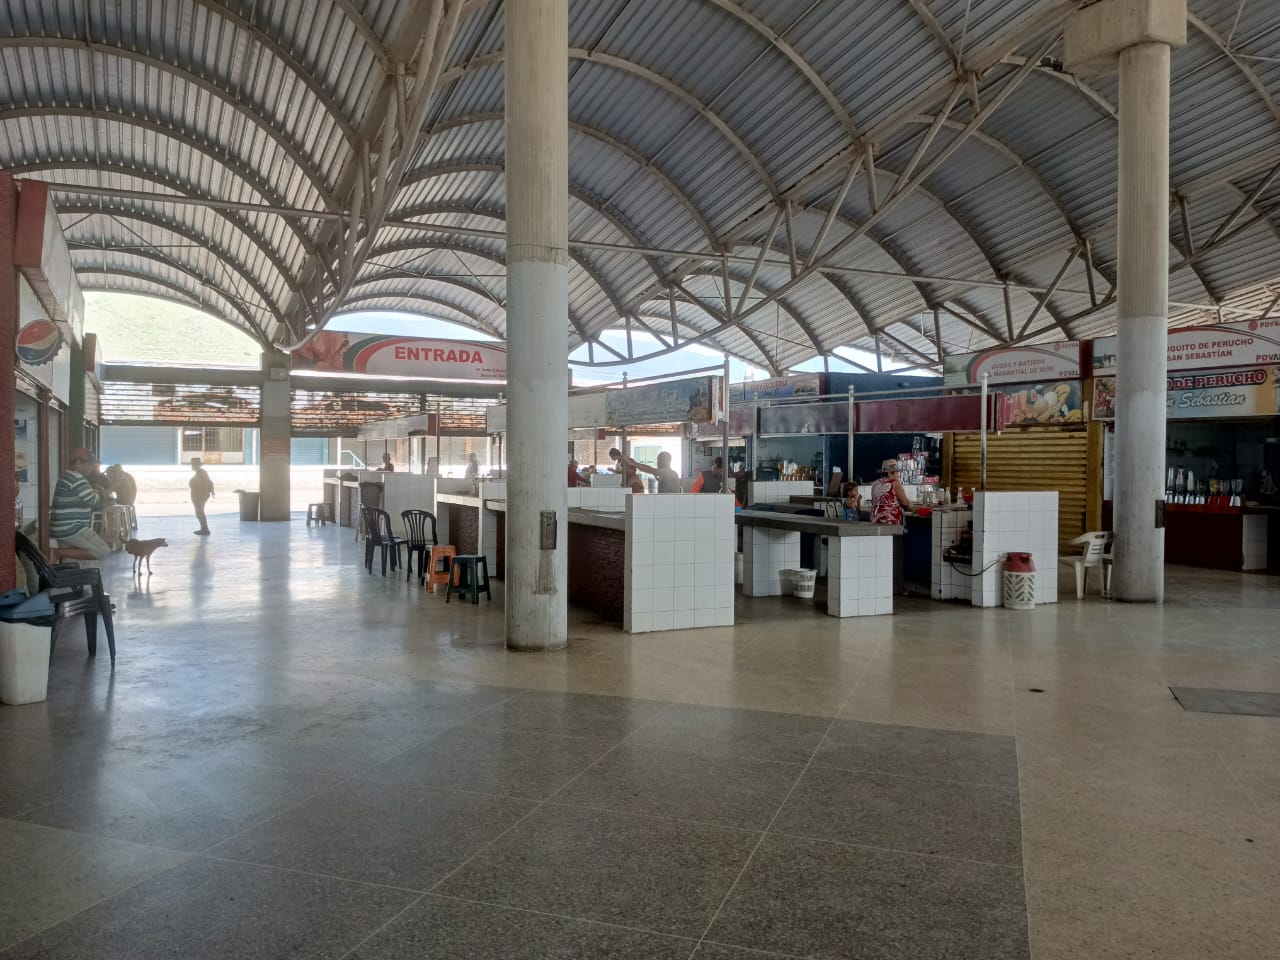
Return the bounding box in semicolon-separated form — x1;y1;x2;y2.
293;330;507;381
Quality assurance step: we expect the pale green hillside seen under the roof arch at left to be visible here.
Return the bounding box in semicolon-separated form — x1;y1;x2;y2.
84;293;262;367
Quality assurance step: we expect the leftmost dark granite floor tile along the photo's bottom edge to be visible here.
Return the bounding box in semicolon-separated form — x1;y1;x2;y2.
4;858;417;960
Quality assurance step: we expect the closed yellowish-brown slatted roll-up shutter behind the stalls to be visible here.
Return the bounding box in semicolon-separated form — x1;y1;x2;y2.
951;429;1089;543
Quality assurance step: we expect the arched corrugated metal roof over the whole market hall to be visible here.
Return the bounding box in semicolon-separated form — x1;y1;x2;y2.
0;0;1280;370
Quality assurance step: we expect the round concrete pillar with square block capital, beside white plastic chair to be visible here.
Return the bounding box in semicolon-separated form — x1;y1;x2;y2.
1064;0;1187;603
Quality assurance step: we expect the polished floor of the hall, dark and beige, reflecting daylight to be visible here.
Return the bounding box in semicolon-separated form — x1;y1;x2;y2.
0;517;1280;960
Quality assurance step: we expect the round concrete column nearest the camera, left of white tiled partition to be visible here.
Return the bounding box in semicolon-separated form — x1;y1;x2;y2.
506;0;568;650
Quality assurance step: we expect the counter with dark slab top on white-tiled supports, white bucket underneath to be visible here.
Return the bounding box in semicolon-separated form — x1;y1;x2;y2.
736;511;902;617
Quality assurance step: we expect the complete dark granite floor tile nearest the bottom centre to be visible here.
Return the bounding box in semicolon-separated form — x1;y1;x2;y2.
434;804;759;937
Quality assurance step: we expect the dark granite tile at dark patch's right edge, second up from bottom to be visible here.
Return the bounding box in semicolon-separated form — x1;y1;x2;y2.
771;765;1023;867
